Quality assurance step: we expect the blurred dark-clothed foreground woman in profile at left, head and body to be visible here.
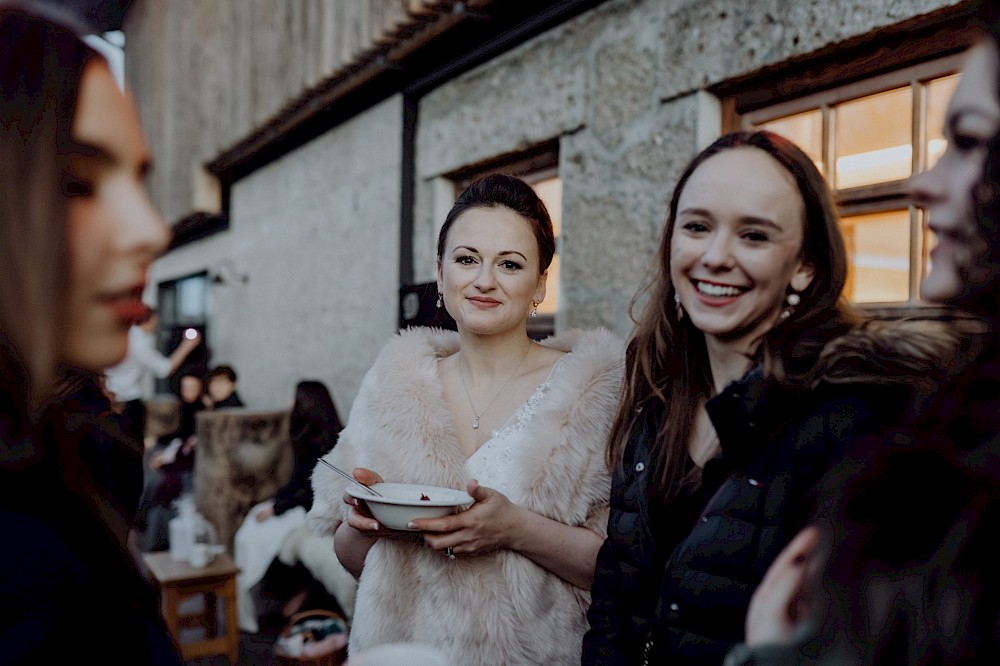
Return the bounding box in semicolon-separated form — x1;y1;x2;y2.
0;2;179;664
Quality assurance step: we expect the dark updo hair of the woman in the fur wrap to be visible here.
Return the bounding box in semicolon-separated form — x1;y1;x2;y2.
438;173;556;273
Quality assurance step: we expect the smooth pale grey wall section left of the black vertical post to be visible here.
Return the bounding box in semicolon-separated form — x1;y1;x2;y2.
153;96;402;418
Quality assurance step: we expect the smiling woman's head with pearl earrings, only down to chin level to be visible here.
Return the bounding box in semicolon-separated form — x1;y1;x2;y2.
656;131;847;358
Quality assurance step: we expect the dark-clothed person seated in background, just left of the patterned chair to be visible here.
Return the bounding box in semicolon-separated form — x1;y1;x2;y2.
136;373;205;551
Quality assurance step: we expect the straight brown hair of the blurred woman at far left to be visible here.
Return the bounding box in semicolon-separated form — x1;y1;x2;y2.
0;3;100;415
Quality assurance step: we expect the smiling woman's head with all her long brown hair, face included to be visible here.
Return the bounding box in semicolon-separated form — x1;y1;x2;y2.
608;131;856;500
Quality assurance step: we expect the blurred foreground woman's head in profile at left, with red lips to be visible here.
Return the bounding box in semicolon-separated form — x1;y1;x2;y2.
0;5;169;404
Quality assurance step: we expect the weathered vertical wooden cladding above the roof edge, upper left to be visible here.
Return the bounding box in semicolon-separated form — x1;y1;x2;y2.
123;0;468;222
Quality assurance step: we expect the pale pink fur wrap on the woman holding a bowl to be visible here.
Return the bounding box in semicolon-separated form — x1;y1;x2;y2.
309;328;624;666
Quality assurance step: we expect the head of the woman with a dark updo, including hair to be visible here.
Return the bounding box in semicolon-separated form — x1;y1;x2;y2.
437;174;555;334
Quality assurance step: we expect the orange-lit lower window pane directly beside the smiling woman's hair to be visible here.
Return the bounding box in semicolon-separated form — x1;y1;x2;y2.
843;209;910;303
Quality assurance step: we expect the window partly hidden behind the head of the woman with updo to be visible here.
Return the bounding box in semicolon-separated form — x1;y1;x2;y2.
451;144;562;339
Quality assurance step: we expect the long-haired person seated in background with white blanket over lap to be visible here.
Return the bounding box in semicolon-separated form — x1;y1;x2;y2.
234;381;343;632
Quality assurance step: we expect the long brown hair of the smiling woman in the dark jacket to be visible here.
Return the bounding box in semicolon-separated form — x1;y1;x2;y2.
608;131;857;500
